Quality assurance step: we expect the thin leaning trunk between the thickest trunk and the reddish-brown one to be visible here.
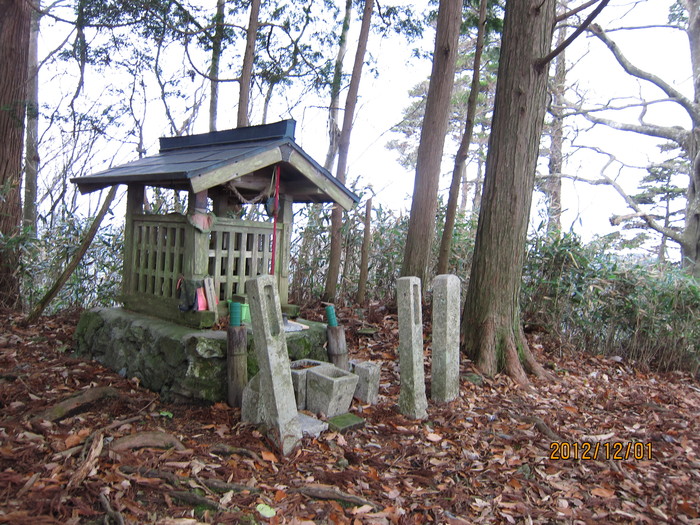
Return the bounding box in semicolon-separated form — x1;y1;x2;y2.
437;0;488;274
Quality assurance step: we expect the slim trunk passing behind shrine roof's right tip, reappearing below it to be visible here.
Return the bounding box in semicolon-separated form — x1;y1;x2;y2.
323;0;374;302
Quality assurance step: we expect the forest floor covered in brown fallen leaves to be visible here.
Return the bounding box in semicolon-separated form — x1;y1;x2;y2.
0;304;700;525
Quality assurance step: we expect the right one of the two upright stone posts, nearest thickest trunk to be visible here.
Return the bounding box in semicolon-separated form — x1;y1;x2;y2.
430;275;460;403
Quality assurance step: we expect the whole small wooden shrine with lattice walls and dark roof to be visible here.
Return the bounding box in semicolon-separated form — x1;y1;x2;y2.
72;120;359;327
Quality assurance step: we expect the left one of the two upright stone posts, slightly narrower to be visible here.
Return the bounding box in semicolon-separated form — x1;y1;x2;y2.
396;277;428;419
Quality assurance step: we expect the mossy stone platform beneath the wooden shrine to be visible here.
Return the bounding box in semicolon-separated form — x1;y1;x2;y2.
75;308;328;402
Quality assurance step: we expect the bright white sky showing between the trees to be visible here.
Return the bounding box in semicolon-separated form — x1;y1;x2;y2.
37;0;691;258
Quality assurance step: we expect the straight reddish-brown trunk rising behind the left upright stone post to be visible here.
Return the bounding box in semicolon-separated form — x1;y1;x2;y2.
401;0;462;283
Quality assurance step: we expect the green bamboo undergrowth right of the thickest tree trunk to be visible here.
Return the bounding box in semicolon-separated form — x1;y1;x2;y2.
521;230;700;373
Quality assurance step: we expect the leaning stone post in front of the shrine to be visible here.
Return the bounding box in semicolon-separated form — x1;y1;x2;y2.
246;275;302;456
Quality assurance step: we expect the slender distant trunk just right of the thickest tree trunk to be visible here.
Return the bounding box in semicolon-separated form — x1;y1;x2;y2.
543;1;567;235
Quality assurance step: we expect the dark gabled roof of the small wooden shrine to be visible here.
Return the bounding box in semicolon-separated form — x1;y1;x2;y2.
71;120;359;209
